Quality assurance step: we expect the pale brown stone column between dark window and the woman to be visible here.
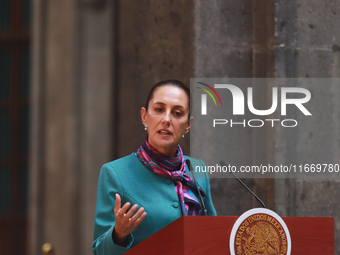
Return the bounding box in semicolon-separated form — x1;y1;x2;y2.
28;0;114;255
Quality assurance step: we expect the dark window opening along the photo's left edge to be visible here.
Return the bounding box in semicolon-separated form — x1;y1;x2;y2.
0;0;31;255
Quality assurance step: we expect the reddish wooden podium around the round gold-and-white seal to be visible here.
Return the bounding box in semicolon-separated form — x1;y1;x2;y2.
125;216;334;255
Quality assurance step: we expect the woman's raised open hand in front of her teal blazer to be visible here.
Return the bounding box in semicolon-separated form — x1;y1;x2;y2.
112;194;146;246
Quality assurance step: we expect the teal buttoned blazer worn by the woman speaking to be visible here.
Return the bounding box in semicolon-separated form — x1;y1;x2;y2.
92;153;216;255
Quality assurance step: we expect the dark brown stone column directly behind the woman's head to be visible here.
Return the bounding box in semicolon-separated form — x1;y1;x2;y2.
114;0;194;158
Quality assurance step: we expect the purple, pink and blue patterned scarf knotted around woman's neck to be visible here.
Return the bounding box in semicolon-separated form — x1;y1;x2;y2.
137;138;205;215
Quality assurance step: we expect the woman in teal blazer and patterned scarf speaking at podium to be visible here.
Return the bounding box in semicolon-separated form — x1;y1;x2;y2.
92;80;216;255
